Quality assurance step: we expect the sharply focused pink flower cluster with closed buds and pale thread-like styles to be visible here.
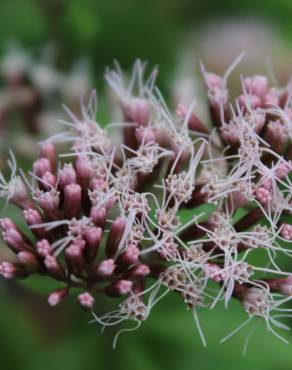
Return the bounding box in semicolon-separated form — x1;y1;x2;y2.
0;58;292;343
